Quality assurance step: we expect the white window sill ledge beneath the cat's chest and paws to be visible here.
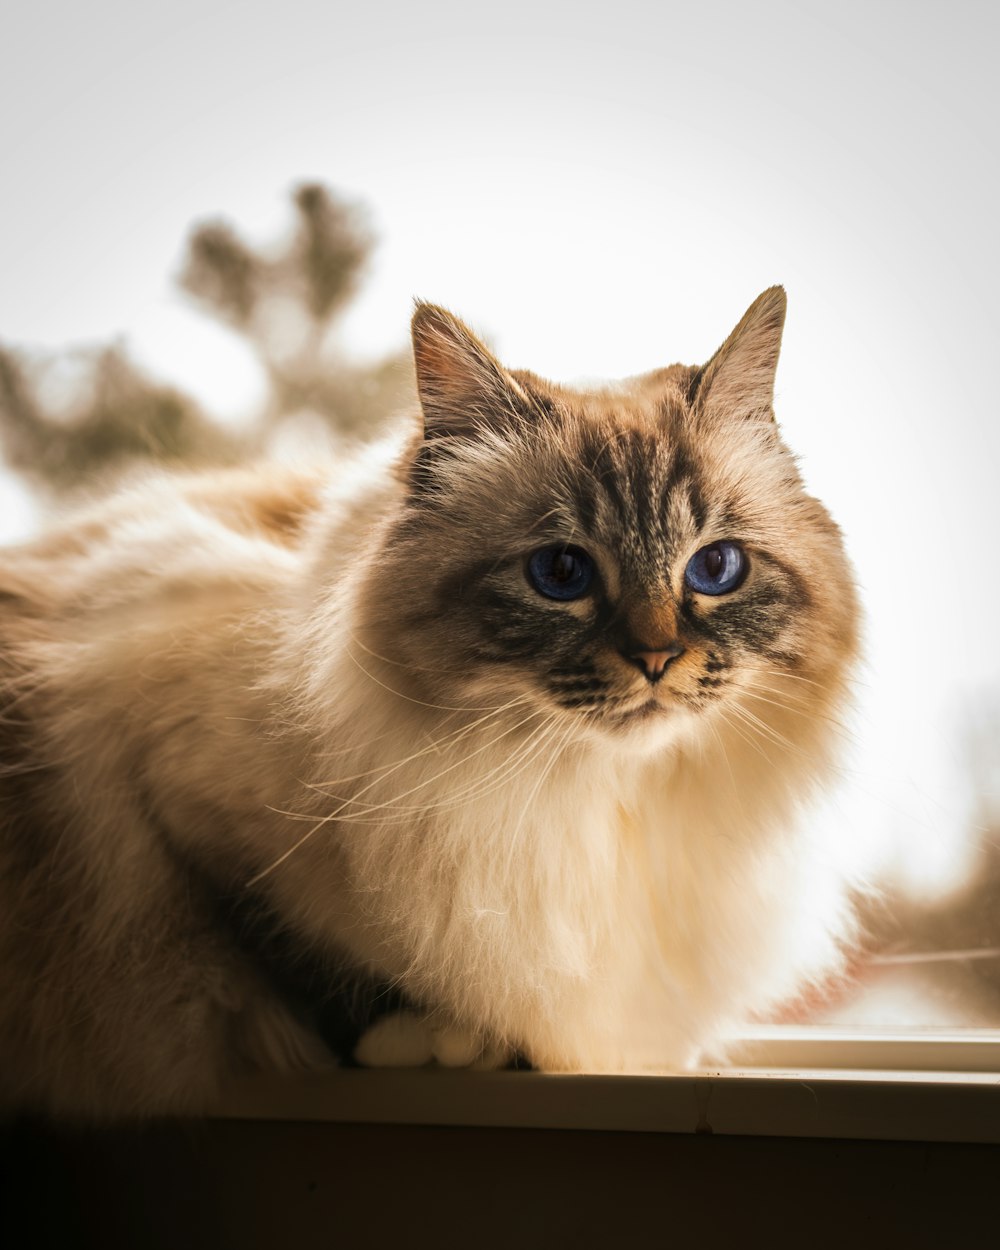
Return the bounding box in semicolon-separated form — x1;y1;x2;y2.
216;1029;1000;1143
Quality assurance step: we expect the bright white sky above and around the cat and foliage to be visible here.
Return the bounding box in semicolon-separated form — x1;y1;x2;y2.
0;0;1000;900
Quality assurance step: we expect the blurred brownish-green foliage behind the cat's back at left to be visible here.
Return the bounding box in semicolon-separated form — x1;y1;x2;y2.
0;185;414;491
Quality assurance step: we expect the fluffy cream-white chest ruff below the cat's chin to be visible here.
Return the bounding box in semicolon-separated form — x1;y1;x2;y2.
274;664;844;1071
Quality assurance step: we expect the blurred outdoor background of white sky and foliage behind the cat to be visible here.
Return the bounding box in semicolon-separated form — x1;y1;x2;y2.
0;0;1000;1028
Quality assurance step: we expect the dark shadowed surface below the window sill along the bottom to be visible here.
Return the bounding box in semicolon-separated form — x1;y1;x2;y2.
0;1121;1000;1250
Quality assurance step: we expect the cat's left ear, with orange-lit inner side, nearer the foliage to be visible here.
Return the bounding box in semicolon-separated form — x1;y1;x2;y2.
413;301;530;438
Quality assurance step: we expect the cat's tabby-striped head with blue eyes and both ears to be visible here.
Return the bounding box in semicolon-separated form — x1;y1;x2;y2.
364;288;856;749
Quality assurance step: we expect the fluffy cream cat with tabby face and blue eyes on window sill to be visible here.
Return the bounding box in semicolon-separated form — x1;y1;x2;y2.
0;288;859;1119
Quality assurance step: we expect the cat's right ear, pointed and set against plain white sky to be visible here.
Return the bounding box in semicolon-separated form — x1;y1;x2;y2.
689;286;788;421
